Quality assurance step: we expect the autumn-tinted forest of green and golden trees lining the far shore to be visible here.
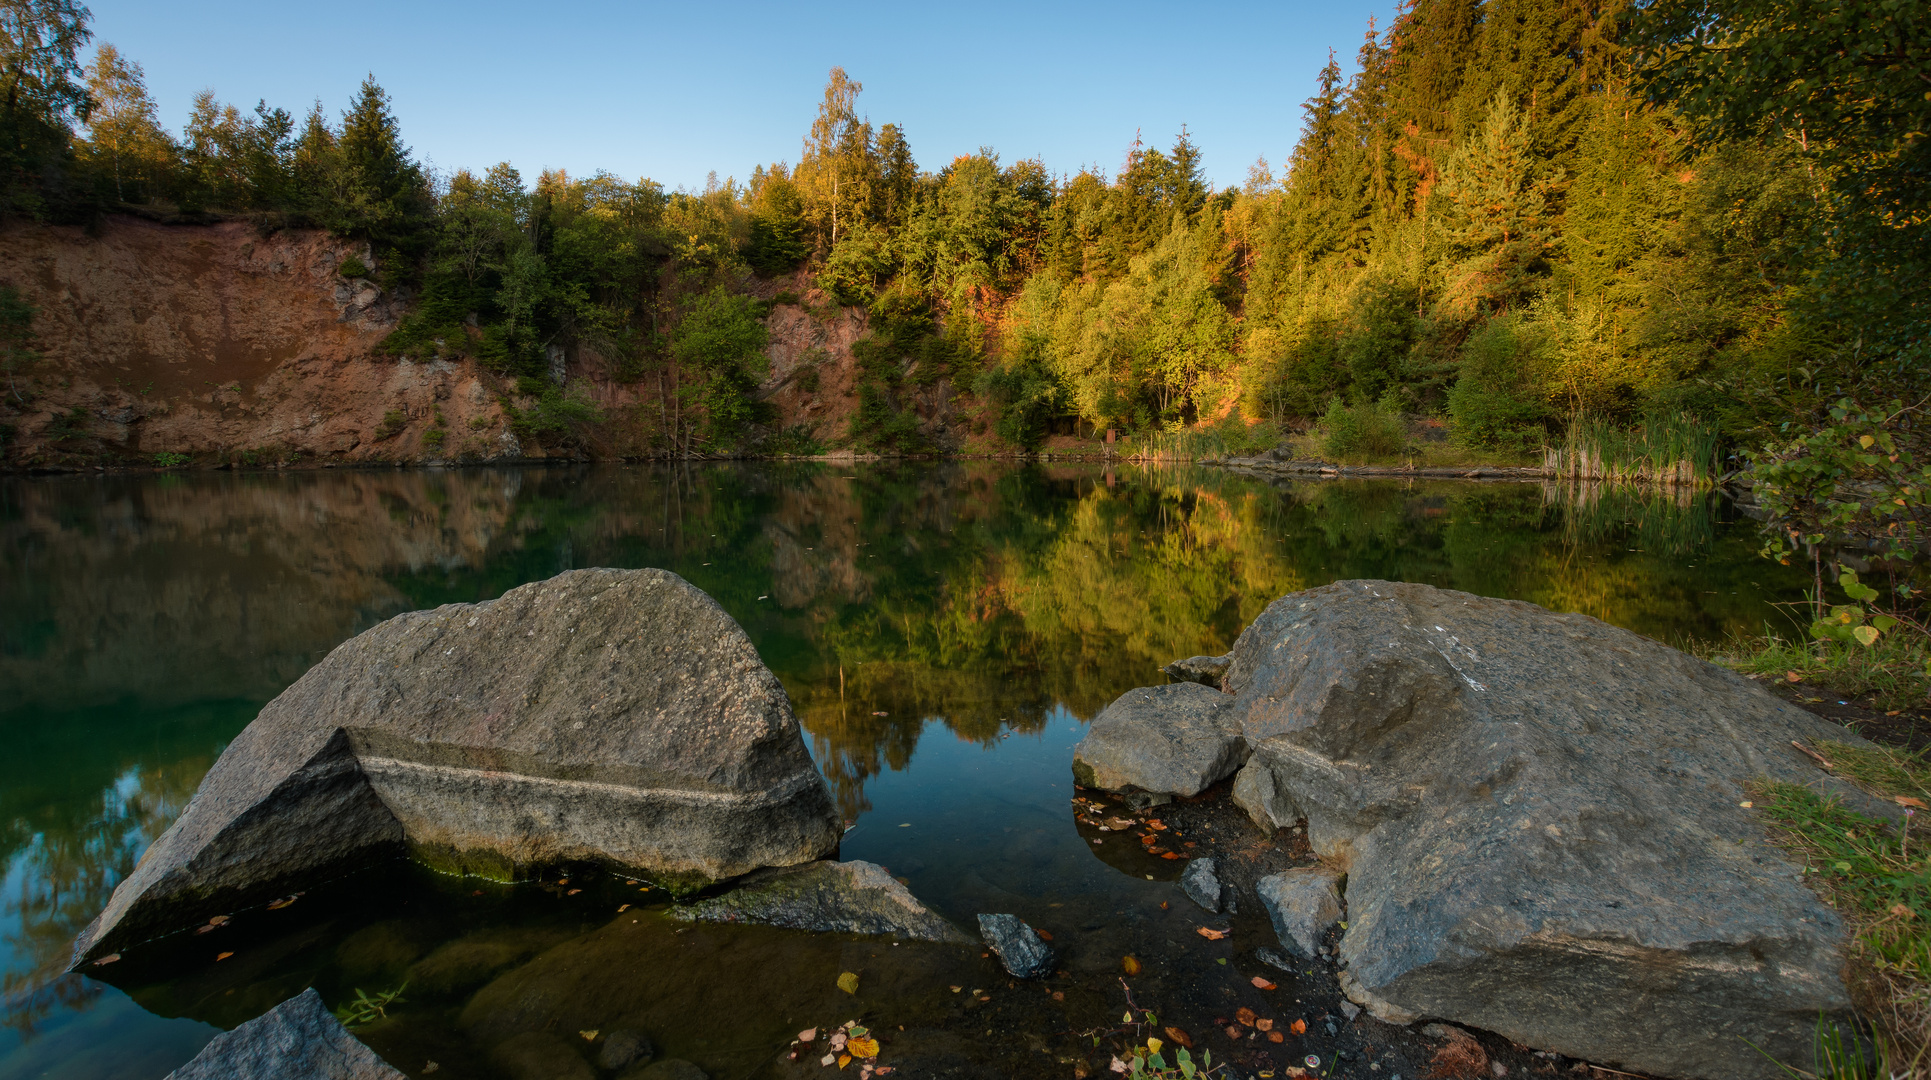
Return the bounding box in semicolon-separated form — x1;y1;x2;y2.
0;0;1931;456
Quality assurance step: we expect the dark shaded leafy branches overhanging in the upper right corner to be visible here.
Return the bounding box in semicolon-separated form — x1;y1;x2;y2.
1630;0;1931;396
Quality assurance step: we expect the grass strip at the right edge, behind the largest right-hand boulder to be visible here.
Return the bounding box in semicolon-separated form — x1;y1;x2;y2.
1703;630;1931;709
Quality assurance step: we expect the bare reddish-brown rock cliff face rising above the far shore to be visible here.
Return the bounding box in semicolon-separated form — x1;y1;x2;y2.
0;216;983;469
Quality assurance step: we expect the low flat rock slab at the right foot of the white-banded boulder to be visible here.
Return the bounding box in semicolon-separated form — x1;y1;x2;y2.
670;860;971;945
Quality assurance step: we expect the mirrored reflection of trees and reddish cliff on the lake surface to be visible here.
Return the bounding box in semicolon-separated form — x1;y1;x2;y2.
0;464;1798;1051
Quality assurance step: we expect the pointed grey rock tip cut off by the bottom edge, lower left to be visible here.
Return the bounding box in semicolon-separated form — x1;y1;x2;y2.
166;987;404;1080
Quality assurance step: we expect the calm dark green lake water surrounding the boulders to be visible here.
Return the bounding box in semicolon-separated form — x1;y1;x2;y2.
0;464;1802;1080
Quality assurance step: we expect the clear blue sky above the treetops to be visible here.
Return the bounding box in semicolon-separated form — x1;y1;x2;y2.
89;0;1394;187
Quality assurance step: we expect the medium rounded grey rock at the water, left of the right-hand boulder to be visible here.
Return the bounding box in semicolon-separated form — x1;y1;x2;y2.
1074;682;1247;796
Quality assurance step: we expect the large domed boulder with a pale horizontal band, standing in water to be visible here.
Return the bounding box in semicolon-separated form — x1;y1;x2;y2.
75;570;842;962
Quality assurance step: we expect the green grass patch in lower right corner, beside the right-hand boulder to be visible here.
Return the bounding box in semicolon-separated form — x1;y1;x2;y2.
1751;742;1931;1076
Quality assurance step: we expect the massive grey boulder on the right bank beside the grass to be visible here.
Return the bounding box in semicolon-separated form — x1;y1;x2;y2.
1226;582;1871;1078
